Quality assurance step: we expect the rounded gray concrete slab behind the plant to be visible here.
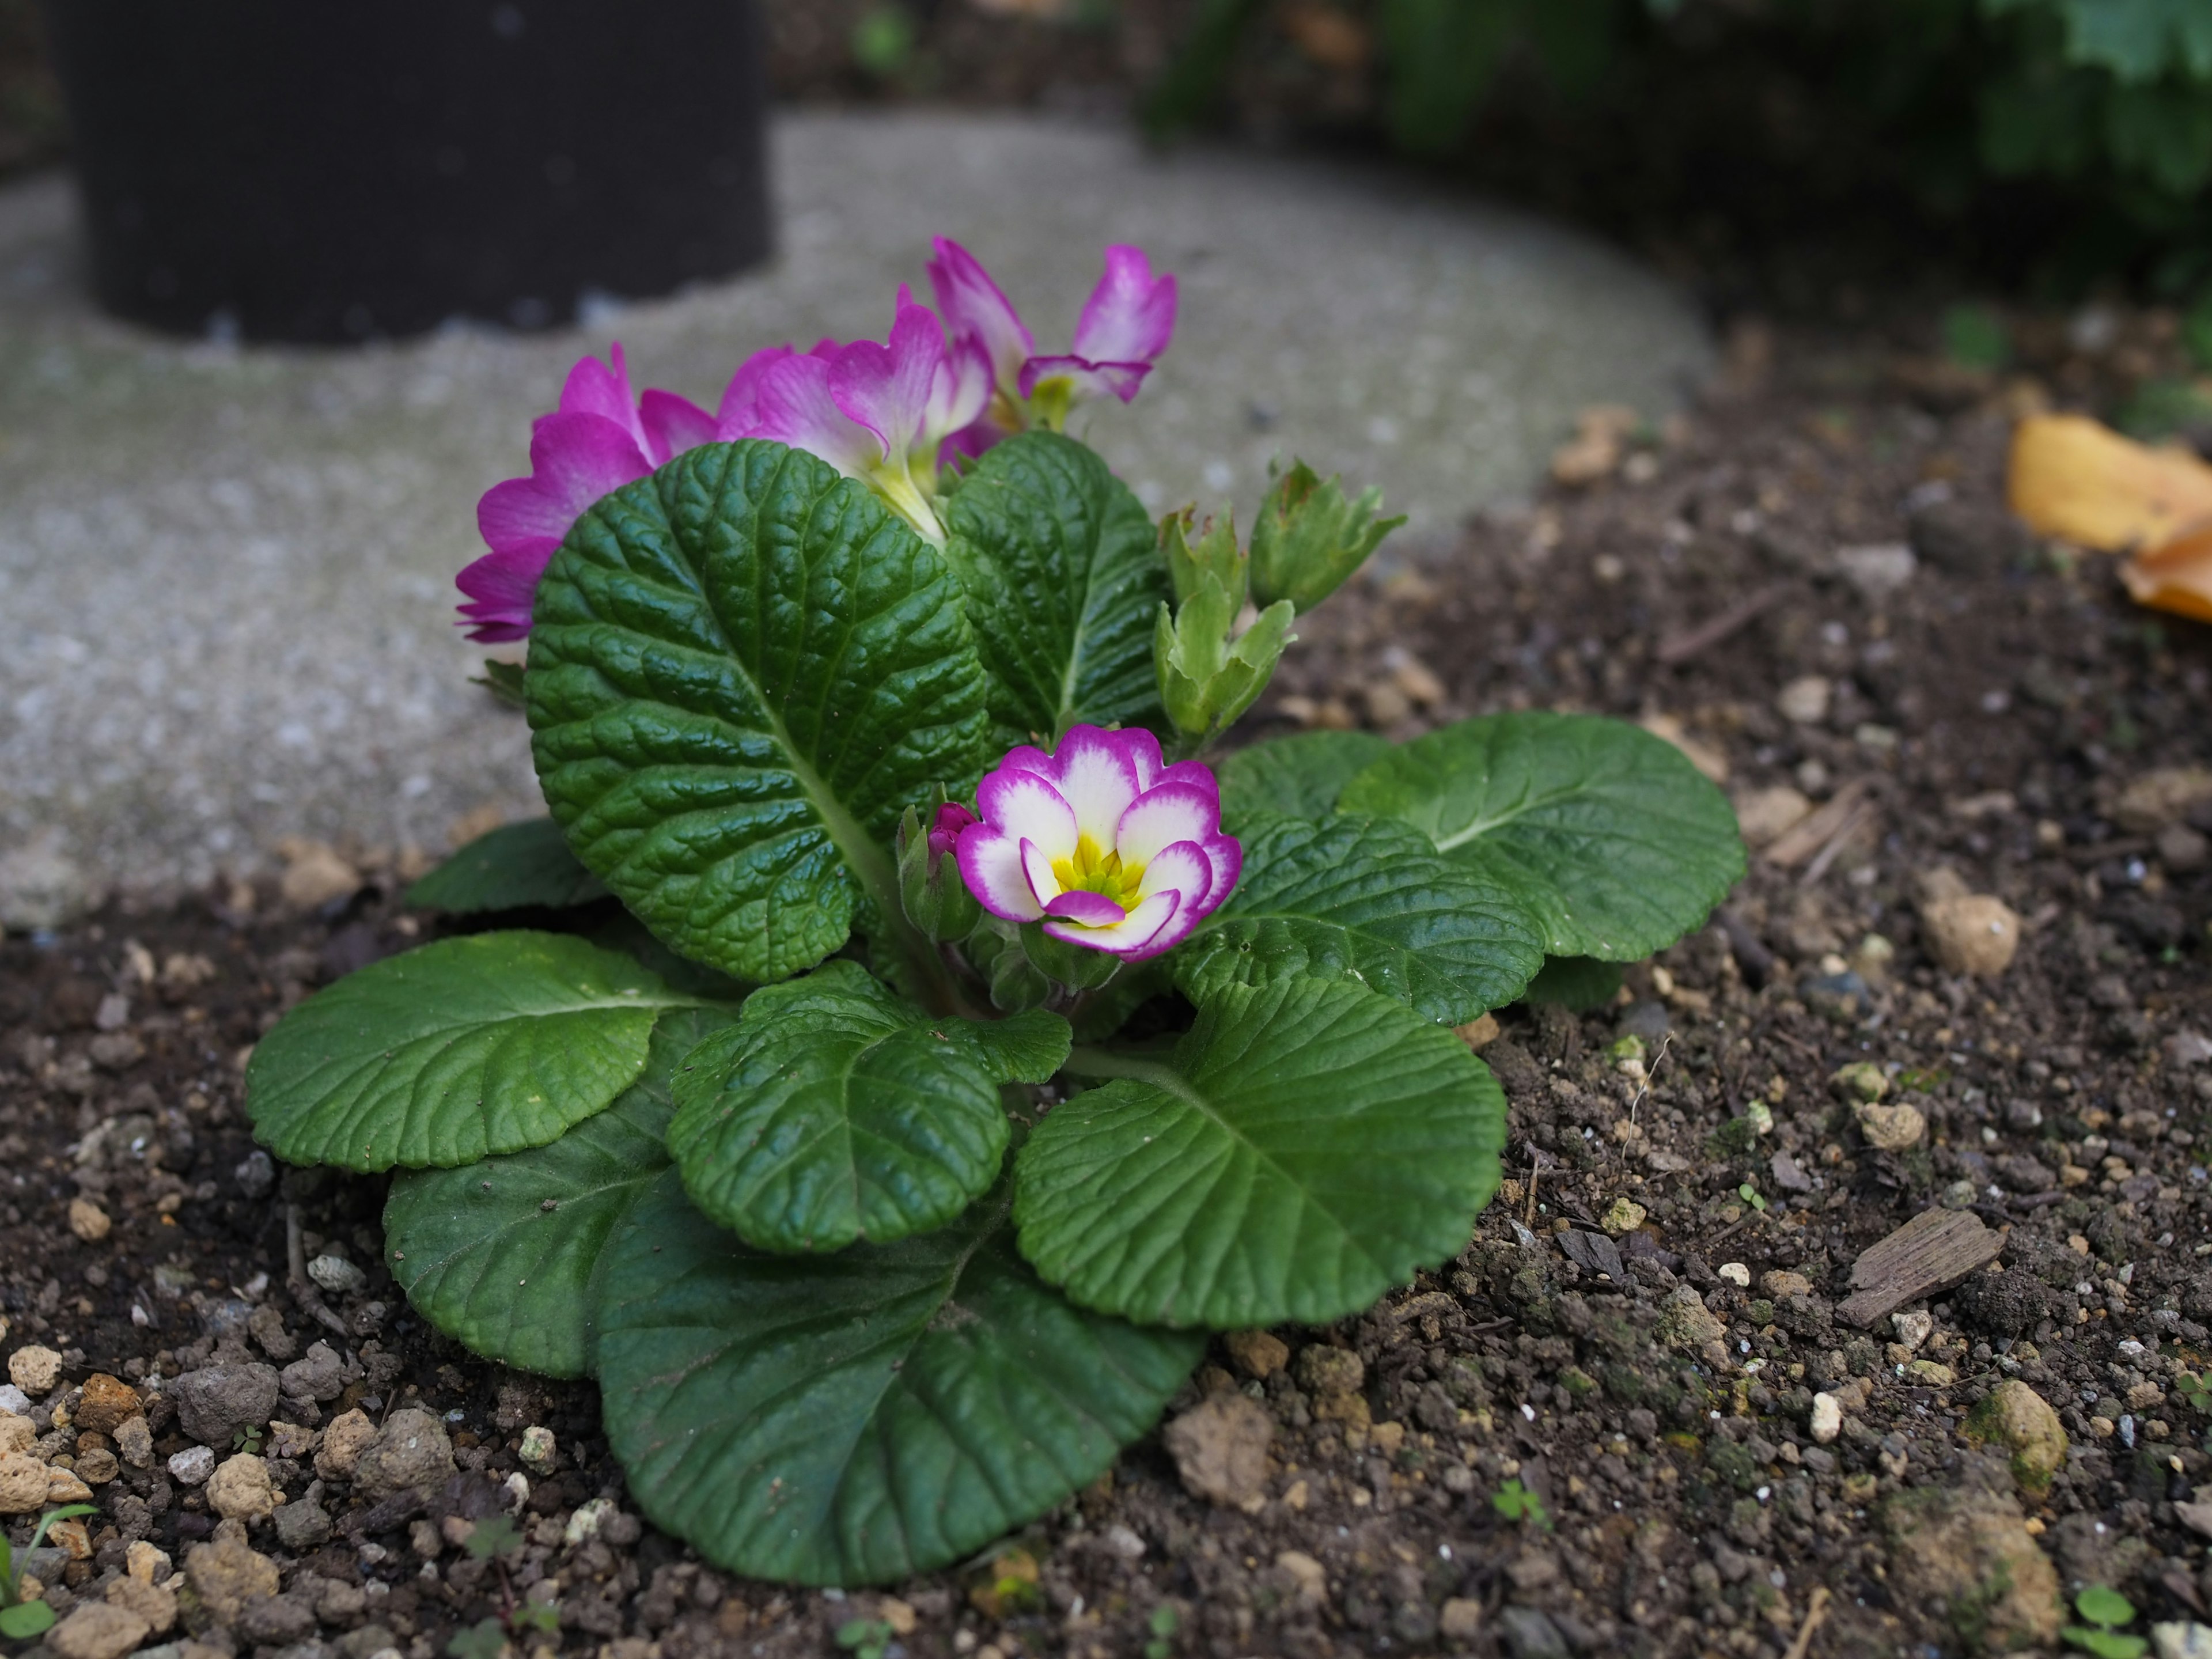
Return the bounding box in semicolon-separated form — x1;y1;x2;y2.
0;113;1710;911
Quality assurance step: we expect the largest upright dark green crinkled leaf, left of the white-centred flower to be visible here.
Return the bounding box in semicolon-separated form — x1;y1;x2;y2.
524;440;986;982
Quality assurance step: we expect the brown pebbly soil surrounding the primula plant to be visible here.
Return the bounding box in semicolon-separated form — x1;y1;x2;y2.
0;314;2212;1659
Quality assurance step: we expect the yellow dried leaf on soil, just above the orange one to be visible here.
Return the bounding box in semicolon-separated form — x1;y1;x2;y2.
2006;416;2212;553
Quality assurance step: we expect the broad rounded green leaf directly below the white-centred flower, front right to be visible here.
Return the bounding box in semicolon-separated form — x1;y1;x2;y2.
1016;980;1506;1330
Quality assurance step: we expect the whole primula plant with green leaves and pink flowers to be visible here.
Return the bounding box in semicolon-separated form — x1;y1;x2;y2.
248;241;1743;1584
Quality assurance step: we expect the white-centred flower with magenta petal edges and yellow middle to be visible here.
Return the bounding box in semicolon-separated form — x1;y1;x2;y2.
958;726;1243;960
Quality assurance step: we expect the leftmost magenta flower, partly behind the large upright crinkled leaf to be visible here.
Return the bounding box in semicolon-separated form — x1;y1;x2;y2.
456;343;690;642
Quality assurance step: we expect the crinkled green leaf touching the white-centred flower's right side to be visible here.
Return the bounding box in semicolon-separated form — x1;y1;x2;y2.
1168;814;1544;1027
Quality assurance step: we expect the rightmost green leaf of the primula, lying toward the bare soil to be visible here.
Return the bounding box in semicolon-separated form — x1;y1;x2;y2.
1338;712;1743;962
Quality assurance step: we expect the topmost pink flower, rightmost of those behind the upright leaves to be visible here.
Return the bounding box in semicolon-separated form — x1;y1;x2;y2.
929;237;1177;442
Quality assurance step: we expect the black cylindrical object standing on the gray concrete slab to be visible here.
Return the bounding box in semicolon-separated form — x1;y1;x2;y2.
44;0;770;340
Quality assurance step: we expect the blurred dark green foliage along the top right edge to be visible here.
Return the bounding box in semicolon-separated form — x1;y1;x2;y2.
1146;0;2212;292
